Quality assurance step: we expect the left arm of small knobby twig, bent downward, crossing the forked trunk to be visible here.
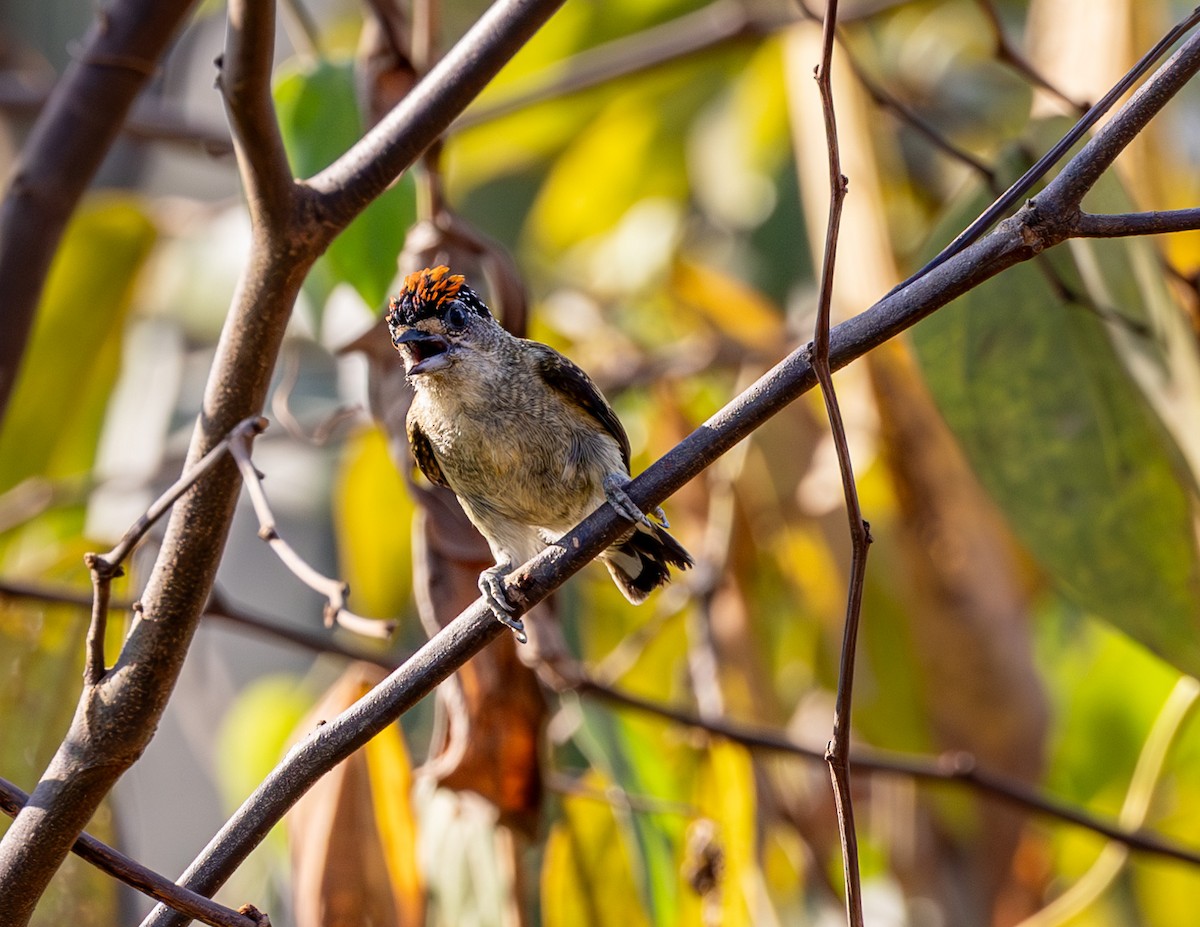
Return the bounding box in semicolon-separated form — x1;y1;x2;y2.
84;417;266;686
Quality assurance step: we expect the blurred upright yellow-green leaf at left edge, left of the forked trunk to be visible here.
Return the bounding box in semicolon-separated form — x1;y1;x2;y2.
0;197;155;492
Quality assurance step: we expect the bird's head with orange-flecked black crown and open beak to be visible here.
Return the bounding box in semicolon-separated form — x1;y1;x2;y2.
386;265;500;377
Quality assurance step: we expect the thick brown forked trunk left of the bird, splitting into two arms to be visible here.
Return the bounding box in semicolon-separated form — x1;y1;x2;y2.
0;0;560;925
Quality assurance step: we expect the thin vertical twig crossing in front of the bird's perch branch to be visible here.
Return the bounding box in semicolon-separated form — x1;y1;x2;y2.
811;0;871;927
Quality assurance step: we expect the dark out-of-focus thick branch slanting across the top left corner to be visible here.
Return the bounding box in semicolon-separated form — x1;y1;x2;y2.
0;0;193;420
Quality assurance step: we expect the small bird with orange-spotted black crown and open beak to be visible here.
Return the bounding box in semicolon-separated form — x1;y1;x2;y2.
386;265;692;641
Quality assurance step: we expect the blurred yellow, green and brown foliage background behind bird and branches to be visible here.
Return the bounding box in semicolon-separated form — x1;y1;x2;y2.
0;0;1200;927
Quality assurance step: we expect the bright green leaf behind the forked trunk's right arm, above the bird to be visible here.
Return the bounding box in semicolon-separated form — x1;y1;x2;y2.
275;60;416;307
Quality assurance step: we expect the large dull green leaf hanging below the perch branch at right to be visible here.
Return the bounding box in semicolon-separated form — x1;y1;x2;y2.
912;123;1200;674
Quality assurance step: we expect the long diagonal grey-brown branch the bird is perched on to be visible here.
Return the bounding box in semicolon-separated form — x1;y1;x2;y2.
138;25;1200;927
